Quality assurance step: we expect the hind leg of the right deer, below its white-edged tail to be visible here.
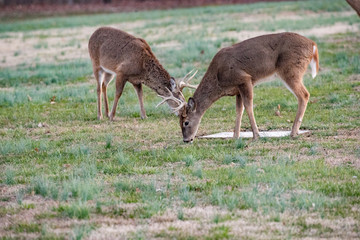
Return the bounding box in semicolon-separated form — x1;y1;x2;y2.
284;77;310;137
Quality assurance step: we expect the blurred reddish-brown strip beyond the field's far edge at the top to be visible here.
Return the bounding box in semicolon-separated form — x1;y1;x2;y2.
0;0;292;17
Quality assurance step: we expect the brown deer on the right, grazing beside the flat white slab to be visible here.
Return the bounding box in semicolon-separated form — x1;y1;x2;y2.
159;32;319;142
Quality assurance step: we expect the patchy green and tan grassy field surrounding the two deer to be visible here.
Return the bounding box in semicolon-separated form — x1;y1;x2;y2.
0;0;360;239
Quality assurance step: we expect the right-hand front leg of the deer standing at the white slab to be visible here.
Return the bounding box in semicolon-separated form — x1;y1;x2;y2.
239;82;260;140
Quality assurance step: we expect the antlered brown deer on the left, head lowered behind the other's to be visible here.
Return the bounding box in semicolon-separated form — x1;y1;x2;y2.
88;27;196;121
